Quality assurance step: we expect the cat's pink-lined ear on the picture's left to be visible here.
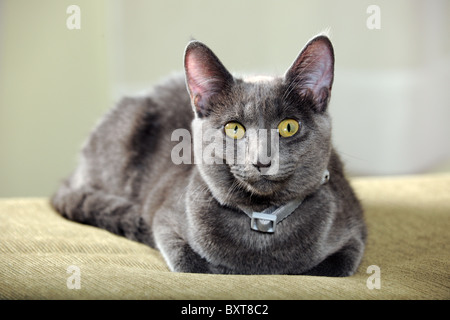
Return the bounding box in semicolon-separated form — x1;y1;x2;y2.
184;41;234;117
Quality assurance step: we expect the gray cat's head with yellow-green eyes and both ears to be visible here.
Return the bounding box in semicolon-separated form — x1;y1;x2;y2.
184;35;334;203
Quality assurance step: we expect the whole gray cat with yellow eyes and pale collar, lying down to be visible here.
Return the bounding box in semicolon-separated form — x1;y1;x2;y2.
52;35;366;276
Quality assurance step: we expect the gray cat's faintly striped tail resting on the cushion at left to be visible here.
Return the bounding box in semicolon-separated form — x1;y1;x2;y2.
50;180;154;247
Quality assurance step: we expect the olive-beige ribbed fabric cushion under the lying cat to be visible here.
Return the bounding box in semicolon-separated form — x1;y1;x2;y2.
0;174;450;299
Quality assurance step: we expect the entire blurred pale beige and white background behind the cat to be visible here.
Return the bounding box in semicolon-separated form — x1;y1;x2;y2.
0;0;450;197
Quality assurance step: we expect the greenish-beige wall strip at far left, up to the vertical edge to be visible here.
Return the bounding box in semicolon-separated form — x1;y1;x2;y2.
0;0;111;196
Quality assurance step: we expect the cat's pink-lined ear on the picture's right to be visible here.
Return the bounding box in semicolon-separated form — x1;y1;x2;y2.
285;35;334;112
